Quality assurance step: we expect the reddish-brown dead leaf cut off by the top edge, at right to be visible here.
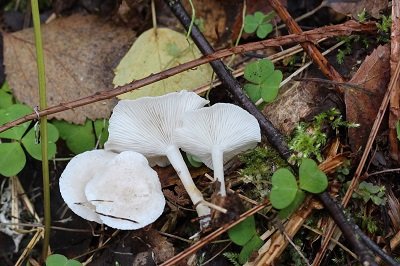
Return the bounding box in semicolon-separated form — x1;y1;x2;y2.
326;0;388;18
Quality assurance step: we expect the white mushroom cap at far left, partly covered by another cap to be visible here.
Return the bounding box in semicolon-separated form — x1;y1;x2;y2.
59;150;116;223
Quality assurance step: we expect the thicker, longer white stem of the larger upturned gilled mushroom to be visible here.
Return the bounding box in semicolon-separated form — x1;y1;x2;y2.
166;145;211;217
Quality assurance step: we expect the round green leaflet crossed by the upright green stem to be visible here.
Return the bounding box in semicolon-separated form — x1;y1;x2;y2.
21;123;59;160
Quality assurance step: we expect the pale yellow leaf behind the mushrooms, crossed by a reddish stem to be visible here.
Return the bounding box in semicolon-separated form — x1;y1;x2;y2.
113;28;212;99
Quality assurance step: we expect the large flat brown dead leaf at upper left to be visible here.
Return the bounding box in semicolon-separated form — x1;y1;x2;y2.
4;14;135;124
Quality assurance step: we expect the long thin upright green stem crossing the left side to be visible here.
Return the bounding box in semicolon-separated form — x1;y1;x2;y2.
31;0;51;261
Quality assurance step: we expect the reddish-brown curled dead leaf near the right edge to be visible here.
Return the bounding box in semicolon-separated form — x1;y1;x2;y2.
345;45;390;151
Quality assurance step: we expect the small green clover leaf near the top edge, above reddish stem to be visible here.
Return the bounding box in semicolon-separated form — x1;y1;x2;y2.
244;11;275;39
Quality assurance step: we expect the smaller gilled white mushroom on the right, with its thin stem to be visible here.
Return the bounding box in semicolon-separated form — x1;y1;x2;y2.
174;103;261;196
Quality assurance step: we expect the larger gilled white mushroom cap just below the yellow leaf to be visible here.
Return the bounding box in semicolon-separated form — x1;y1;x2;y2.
104;91;208;163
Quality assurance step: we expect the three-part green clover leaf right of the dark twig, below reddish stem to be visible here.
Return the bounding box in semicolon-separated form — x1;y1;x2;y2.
244;59;283;102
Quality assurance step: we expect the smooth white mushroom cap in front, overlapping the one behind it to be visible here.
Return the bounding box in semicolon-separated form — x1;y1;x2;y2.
85;151;165;230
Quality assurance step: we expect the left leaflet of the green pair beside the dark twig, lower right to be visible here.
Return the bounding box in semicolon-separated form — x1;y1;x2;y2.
269;168;298;209
